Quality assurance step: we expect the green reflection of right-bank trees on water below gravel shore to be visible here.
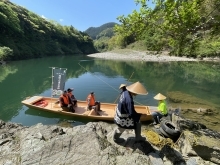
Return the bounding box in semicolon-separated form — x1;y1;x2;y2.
89;60;220;103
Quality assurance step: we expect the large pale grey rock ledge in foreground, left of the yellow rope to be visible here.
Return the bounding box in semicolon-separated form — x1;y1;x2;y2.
0;120;218;165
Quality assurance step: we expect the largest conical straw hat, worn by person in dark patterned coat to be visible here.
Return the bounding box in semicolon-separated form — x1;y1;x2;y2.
126;81;148;95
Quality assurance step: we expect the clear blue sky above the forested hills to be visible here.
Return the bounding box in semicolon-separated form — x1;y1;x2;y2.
10;0;150;31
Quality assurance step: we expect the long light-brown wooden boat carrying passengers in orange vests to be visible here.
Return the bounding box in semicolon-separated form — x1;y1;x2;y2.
22;96;152;121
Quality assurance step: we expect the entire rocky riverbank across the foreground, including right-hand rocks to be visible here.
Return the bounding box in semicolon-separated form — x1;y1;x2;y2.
0;116;220;165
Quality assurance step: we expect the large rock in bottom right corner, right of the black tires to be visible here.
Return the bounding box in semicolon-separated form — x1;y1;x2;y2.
172;115;220;164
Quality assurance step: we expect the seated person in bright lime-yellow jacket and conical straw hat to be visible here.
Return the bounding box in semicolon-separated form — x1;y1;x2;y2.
151;93;168;125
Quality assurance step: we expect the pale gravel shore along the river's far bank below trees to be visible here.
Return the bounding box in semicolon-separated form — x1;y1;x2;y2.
88;50;199;62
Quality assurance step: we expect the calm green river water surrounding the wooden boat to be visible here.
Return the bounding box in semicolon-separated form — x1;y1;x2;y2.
0;56;220;131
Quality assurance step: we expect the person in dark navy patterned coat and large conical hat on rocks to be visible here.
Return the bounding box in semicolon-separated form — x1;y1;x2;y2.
113;82;147;143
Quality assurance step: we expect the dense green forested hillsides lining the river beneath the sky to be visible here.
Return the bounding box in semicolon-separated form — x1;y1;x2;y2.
0;0;220;62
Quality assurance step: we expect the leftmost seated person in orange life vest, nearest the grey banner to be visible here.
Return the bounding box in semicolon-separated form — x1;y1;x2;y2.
59;91;75;112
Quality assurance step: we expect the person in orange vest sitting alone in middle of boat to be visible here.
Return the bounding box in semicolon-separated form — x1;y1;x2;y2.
86;92;101;116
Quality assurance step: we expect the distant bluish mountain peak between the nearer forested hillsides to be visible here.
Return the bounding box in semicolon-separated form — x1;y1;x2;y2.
84;22;117;40
